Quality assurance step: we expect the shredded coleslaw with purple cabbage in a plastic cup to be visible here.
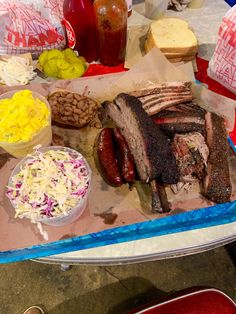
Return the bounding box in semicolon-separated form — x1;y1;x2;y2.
6;149;90;223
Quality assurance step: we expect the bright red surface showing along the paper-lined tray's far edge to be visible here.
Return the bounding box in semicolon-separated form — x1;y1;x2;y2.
84;57;236;145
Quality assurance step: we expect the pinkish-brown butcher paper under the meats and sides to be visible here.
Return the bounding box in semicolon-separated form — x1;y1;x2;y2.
0;50;236;251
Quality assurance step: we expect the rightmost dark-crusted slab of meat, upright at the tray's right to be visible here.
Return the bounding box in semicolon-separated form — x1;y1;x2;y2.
203;112;232;203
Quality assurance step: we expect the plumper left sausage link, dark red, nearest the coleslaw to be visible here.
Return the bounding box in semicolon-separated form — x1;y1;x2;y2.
97;128;123;186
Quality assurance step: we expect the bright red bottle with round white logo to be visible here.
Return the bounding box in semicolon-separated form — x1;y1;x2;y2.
63;0;97;62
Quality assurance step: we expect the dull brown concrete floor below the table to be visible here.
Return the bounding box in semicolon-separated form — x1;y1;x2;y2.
0;247;236;314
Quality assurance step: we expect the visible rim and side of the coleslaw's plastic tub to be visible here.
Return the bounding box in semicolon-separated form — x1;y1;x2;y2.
8;146;92;226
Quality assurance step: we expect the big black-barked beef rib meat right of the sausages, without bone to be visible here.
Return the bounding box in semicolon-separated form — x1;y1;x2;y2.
104;93;179;184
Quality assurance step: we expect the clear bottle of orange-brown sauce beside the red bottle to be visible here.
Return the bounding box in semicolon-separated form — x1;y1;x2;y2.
93;0;128;66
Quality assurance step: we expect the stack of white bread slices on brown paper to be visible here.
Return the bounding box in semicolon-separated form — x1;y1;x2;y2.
144;17;198;62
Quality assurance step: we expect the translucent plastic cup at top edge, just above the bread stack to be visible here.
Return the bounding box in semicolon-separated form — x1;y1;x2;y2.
145;0;168;20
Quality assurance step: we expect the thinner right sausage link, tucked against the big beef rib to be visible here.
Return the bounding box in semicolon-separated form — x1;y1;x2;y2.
113;128;135;182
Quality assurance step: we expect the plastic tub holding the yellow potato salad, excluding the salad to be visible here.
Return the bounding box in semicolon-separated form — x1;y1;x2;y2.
0;90;52;158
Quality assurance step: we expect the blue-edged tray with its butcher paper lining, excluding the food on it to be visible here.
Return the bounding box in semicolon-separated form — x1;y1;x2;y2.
0;53;236;263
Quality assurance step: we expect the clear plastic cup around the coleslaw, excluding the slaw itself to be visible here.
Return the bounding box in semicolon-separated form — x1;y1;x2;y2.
7;146;92;226
